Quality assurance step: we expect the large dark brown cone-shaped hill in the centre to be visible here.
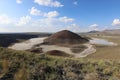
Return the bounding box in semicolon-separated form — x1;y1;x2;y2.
44;30;89;45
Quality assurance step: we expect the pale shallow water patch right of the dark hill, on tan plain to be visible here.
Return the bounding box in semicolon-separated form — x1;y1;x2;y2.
90;38;117;46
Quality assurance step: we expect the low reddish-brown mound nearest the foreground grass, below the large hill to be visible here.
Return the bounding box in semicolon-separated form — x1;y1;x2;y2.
46;50;71;57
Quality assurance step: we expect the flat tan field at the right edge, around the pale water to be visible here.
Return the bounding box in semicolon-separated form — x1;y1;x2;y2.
87;34;120;59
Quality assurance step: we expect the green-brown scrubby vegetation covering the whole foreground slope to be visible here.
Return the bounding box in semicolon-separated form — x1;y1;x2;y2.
0;48;120;80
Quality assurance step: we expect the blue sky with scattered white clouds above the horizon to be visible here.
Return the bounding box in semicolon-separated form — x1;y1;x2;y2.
0;0;120;33
